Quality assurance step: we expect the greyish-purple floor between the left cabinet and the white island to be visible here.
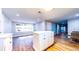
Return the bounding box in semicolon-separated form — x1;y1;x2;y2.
13;36;33;51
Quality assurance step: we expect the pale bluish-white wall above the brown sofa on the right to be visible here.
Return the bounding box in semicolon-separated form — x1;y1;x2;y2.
68;19;79;35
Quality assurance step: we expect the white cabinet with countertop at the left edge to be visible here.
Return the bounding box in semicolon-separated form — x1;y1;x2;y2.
0;34;12;51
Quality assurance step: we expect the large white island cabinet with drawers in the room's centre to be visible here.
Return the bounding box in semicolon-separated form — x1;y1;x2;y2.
33;31;54;51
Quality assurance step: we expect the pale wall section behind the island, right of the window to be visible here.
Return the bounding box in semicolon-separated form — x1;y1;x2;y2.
35;21;52;31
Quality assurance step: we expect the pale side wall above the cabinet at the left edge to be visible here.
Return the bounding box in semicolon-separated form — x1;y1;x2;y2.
0;9;12;33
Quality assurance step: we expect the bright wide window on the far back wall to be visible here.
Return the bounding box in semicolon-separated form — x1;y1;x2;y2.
16;24;33;32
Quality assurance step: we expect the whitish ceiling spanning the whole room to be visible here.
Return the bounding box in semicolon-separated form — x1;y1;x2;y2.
2;8;79;22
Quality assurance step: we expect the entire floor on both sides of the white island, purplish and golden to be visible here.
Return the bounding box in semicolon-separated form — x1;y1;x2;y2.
13;36;79;51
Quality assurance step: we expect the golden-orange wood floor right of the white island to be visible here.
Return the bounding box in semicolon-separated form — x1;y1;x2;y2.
46;37;79;51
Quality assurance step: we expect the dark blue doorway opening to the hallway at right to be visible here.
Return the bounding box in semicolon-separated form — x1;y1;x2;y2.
56;21;68;37
